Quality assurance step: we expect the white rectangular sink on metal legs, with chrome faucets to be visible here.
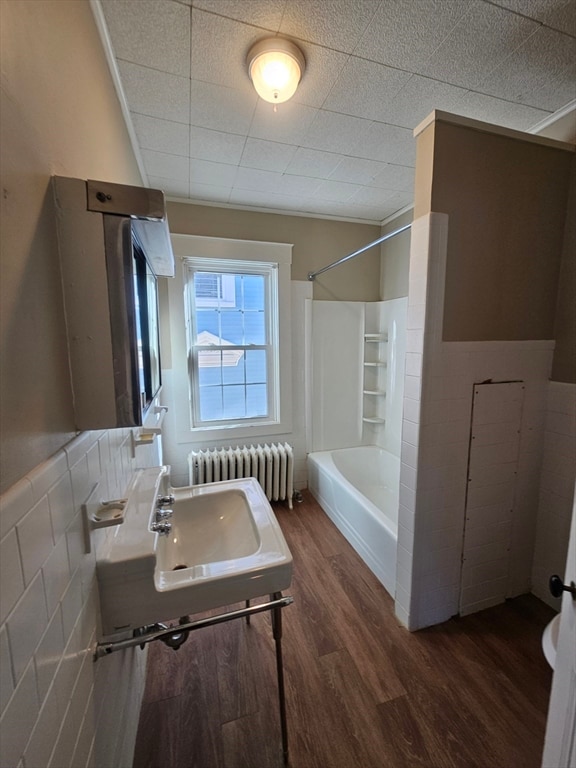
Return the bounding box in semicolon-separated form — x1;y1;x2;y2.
97;468;292;636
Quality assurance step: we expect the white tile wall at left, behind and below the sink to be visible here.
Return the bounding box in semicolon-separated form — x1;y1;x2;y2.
0;430;156;768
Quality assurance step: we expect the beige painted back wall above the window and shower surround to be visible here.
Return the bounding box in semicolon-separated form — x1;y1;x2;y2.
168;202;380;301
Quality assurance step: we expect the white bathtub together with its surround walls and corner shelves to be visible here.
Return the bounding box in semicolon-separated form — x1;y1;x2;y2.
308;299;407;596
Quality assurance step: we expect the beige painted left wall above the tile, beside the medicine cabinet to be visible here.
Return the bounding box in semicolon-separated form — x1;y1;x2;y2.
0;0;141;490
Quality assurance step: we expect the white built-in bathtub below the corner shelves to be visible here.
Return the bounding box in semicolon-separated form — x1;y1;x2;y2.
308;445;400;597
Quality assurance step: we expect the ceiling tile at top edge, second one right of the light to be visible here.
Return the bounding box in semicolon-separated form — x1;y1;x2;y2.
353;0;472;72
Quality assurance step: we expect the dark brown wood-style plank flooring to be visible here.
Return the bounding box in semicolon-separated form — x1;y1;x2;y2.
134;493;553;768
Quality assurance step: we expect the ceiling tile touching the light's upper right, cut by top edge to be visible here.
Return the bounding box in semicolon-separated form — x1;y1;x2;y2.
280;0;377;53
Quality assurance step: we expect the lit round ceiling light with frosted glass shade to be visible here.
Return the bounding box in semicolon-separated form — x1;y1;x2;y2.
246;37;306;104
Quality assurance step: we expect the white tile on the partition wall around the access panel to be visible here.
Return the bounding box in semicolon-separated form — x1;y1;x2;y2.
396;213;553;629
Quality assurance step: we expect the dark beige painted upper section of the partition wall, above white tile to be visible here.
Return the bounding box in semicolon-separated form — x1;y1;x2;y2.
430;121;572;341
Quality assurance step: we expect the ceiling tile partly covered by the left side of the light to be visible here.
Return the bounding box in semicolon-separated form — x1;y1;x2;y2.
191;8;262;96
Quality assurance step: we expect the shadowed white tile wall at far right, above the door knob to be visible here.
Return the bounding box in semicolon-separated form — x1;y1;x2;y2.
532;381;576;610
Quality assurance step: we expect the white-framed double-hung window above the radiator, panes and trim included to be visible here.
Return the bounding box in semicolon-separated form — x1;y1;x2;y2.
162;235;292;445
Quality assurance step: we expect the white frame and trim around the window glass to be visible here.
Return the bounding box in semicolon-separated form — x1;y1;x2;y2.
164;235;292;443
